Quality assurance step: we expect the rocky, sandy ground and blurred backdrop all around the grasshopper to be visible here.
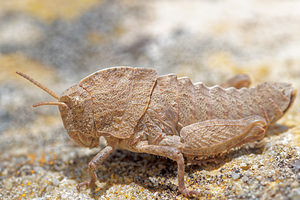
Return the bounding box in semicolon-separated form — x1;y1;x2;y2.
0;0;300;199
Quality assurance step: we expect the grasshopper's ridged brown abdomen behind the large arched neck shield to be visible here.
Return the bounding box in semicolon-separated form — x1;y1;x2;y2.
140;75;291;141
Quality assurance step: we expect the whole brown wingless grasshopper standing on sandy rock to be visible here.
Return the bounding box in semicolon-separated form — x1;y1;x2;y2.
17;67;296;196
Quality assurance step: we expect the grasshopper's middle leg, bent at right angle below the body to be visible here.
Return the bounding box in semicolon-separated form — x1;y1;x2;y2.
136;142;199;197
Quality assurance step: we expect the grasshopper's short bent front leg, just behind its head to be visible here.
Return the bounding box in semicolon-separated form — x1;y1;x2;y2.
77;146;113;190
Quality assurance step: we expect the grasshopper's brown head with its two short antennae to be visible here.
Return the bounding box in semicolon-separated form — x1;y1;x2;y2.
17;72;99;148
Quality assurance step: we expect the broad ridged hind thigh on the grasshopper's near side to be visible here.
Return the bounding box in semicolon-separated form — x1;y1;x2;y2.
180;115;267;159
